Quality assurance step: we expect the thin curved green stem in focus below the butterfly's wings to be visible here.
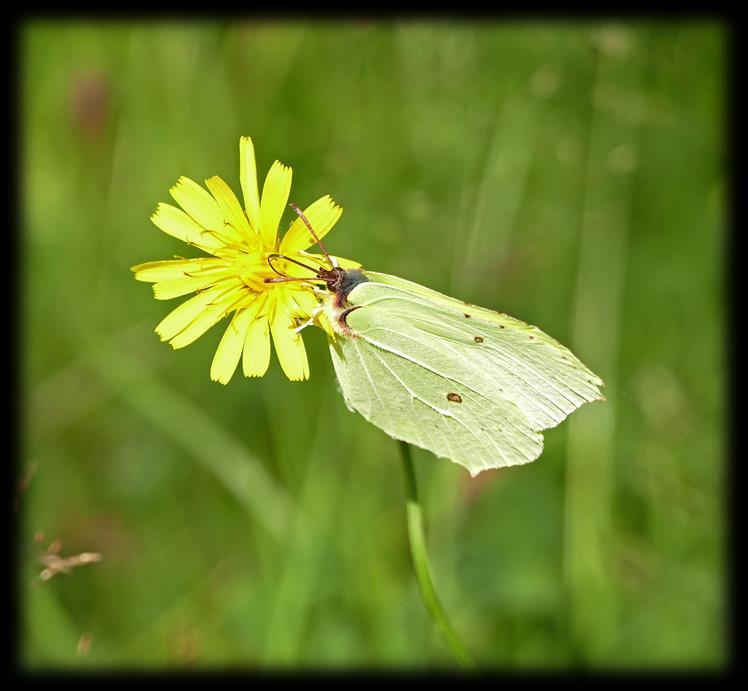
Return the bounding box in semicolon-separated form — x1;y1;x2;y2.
398;441;473;669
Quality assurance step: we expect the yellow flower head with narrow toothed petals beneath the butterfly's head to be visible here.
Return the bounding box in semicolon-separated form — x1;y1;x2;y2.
132;137;358;384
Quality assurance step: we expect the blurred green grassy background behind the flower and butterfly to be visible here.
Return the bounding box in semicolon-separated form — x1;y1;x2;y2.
18;20;727;669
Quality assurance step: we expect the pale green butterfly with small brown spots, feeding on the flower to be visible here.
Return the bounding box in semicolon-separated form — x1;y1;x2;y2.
269;205;603;475
